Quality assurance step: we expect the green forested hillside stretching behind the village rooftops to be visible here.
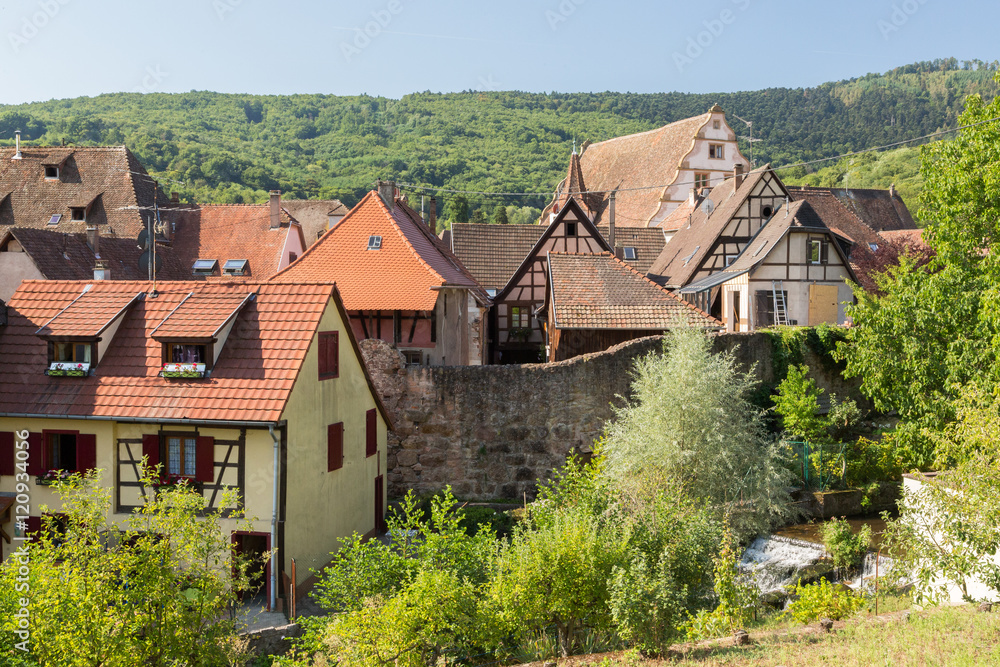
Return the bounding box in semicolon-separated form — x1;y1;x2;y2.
0;59;998;214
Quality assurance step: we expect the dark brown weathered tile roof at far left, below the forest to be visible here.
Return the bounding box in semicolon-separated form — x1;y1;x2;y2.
0;146;167;239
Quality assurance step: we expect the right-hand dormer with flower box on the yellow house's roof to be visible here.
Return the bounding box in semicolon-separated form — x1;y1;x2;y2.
151;292;255;378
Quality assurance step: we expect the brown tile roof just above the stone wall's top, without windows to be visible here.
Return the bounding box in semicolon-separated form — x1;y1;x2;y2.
546;253;722;331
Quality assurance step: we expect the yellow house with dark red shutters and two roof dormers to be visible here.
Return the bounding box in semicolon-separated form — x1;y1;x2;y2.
0;281;391;607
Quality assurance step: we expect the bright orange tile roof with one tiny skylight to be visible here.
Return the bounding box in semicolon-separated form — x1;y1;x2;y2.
275;191;487;311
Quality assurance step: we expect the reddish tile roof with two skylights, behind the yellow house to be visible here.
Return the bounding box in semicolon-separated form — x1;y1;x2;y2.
171;204;305;280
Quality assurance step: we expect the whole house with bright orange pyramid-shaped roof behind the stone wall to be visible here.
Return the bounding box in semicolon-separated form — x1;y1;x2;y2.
274;183;490;366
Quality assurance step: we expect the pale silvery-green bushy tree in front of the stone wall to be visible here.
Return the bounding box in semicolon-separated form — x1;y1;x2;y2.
606;330;793;538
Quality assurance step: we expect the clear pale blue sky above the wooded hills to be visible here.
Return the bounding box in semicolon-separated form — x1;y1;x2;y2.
0;0;1000;104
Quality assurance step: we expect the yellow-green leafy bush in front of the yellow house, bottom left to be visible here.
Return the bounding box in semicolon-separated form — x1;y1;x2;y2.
0;471;263;667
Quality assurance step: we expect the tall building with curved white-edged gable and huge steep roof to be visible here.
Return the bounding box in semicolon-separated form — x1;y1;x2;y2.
540;105;750;231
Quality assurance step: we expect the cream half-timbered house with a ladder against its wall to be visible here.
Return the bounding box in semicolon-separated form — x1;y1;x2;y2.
679;201;857;331
